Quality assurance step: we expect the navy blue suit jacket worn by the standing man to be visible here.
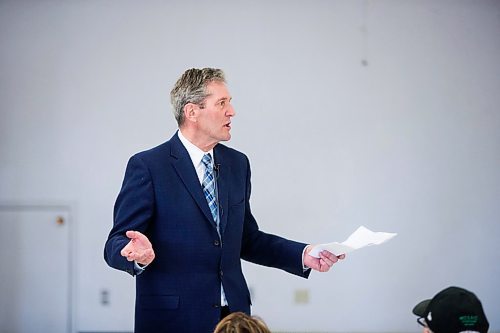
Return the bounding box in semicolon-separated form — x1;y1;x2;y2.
104;133;309;333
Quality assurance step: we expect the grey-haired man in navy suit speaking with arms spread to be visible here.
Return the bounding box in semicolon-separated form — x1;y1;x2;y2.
104;68;344;333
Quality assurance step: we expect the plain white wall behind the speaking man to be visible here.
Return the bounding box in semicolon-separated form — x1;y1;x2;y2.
0;0;500;332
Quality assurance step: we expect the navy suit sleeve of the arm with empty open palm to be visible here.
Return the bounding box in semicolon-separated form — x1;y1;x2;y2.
104;156;155;275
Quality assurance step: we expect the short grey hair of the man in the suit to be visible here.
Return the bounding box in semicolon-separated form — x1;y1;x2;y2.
170;68;226;127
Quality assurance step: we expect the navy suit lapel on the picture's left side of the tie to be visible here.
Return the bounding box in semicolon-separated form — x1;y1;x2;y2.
170;133;215;227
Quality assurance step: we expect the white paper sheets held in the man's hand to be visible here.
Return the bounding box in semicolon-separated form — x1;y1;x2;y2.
309;226;397;258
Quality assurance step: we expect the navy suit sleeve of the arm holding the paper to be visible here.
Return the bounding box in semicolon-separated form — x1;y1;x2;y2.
241;159;310;278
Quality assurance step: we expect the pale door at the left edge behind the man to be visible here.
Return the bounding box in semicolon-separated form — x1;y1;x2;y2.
0;205;71;333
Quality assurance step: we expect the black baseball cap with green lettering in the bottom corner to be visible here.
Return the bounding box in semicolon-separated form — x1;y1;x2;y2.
413;287;490;333
